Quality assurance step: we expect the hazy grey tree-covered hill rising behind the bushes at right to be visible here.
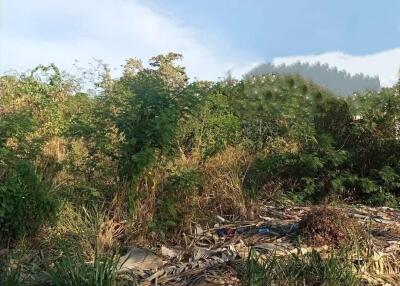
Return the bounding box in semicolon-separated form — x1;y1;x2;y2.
245;62;380;95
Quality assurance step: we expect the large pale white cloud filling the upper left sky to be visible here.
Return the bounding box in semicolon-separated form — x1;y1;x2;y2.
0;0;255;79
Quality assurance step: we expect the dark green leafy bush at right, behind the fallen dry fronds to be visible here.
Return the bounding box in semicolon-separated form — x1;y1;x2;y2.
246;92;400;206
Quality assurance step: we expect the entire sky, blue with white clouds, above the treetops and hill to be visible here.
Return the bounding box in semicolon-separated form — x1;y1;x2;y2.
0;0;400;85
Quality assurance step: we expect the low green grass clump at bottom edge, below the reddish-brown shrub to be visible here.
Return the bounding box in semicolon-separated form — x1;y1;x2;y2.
244;249;359;286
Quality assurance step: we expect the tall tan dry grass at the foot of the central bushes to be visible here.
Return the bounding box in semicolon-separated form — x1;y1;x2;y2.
109;147;252;245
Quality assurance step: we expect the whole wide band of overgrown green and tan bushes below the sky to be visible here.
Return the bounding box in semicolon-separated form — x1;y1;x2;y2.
0;53;400;285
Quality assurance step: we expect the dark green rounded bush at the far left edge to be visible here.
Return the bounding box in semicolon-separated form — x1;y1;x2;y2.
0;161;57;241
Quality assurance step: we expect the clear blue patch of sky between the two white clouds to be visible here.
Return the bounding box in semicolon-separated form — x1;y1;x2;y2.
150;0;400;58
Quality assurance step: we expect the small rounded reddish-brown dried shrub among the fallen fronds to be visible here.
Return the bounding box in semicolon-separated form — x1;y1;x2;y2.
299;207;365;247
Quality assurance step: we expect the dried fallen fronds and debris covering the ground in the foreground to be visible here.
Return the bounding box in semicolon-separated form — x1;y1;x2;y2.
115;206;400;286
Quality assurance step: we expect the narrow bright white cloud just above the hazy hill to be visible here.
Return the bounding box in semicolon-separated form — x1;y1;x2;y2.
273;48;400;87
